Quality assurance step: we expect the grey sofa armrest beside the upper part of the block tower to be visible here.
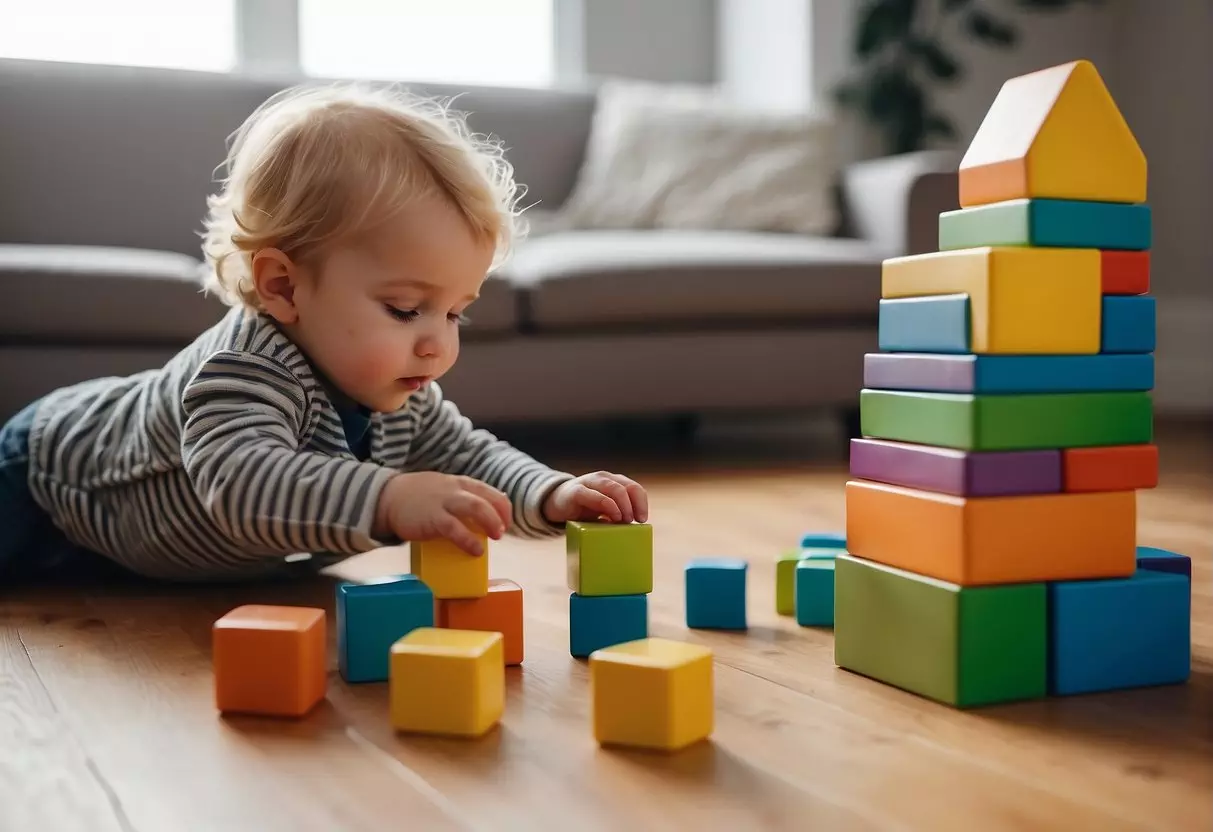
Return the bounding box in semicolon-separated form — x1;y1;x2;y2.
842;150;959;257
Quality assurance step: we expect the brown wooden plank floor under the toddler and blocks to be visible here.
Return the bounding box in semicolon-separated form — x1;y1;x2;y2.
0;419;1213;832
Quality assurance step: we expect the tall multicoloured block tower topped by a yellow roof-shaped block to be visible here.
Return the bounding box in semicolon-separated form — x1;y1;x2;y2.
835;61;1190;707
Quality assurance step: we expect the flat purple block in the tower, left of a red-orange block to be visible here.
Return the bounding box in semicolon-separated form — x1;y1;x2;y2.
850;439;1061;497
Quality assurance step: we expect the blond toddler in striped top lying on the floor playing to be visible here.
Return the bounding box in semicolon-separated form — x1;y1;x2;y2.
0;85;648;581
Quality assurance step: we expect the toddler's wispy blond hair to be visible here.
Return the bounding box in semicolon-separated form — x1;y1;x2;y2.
203;84;524;308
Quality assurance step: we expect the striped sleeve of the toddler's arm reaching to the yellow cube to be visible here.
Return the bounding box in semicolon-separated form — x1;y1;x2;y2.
182;351;395;554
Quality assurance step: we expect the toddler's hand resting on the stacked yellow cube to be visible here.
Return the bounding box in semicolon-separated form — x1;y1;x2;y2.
375;472;513;554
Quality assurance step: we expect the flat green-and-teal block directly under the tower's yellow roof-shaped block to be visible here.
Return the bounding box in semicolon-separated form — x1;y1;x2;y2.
939;199;1152;251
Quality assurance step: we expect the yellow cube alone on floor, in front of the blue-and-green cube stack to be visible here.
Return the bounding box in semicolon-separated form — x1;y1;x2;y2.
590;638;716;751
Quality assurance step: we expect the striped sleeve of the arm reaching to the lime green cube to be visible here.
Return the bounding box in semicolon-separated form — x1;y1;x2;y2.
408;382;573;537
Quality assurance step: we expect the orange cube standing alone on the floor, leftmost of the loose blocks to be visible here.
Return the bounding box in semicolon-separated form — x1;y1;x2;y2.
211;604;329;717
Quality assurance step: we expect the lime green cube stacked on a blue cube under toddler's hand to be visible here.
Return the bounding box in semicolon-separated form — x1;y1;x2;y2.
564;522;653;595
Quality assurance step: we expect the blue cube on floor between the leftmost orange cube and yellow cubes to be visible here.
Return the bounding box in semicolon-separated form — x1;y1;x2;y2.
336;575;434;682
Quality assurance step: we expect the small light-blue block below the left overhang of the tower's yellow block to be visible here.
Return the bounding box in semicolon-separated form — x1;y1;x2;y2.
877;295;969;353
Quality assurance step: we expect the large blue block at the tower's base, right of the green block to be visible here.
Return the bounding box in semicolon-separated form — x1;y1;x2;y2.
1049;569;1191;696
